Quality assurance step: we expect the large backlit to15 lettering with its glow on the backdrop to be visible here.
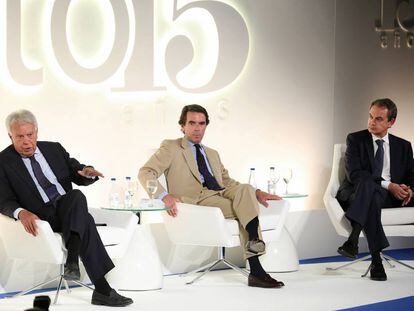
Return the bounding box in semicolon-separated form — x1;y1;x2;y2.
4;0;250;93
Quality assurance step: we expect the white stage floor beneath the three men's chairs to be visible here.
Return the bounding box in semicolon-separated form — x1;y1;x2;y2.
0;258;414;311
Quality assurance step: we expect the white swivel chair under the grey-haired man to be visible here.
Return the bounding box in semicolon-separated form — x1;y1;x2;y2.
0;209;138;304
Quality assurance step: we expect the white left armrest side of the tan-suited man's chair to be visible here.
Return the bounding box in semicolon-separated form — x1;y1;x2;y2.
163;203;240;247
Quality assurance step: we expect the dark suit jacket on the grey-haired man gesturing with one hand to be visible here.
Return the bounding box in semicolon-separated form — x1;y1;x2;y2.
0;142;97;219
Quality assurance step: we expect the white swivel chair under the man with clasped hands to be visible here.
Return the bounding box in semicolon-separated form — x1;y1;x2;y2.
323;144;414;276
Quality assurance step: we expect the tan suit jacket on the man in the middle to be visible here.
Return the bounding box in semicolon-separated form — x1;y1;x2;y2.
138;138;239;204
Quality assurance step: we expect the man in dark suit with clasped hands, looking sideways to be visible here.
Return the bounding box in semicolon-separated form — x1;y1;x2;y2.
337;98;414;281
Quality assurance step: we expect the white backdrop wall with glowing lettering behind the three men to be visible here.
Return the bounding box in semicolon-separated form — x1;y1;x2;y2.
0;0;414;209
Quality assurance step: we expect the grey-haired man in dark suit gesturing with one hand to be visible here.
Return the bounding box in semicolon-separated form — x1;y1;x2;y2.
0;110;132;306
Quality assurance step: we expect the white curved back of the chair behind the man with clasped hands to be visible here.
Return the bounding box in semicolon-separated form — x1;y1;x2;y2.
323;144;351;237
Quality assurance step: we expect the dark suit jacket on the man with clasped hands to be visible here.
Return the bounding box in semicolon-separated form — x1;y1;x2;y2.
337;130;414;202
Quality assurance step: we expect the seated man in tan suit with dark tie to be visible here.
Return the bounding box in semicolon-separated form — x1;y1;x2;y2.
139;105;284;288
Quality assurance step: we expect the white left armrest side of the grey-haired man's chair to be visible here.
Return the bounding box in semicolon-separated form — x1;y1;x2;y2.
0;215;66;264
